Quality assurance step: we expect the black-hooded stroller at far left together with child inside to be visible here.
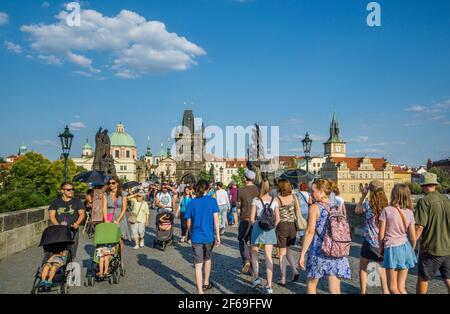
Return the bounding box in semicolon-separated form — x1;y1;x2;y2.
31;225;73;294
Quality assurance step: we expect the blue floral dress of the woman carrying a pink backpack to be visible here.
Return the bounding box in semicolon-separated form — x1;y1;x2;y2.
306;203;351;279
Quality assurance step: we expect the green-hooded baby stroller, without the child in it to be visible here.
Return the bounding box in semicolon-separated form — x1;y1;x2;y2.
86;223;125;286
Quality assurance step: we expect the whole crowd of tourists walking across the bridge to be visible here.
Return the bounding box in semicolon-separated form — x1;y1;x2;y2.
49;169;450;294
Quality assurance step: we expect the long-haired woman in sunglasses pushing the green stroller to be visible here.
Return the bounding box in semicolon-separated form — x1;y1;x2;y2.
102;177;132;268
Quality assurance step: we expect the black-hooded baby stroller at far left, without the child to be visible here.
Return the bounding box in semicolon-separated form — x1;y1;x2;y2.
31;225;74;294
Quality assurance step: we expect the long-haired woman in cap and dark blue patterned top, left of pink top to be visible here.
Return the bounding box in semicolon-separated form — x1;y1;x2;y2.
355;180;389;294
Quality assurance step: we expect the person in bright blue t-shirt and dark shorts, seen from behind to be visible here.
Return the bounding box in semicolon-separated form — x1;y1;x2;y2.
185;180;220;294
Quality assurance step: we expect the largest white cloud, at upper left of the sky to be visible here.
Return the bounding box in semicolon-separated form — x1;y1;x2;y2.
21;10;206;79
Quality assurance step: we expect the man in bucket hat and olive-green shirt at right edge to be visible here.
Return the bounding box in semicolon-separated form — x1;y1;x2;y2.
415;172;450;294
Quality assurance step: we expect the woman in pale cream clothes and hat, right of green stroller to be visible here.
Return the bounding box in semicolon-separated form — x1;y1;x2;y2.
127;193;150;250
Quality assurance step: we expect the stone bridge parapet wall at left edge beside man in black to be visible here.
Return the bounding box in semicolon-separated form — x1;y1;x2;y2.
0;207;48;259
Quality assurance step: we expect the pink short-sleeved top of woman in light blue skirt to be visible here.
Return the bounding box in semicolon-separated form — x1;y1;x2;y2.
380;206;415;248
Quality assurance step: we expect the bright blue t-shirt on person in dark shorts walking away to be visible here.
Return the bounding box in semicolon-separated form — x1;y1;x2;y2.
184;196;220;244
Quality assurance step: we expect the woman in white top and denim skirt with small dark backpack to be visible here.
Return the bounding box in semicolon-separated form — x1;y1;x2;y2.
250;180;280;294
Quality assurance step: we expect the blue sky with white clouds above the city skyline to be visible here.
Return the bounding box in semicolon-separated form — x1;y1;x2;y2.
0;0;450;165
